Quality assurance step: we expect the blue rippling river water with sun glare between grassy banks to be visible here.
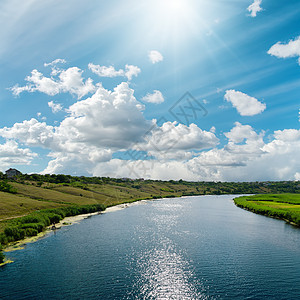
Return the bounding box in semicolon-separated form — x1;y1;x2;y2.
0;195;300;300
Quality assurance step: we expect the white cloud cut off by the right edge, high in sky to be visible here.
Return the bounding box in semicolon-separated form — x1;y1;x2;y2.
268;36;300;65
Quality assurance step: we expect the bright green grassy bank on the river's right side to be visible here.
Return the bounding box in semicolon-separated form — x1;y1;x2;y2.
234;194;300;226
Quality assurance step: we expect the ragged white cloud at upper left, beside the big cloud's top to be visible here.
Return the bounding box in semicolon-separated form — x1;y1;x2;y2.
11;67;95;99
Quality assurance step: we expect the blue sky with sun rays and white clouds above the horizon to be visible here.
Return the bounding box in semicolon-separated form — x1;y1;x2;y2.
0;0;300;181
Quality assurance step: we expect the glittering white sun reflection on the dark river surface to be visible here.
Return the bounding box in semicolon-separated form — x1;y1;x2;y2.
127;203;208;299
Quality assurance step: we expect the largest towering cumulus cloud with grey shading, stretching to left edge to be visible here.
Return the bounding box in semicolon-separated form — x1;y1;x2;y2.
0;82;152;153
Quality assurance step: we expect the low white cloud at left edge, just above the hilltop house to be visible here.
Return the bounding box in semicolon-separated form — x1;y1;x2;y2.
0;141;37;171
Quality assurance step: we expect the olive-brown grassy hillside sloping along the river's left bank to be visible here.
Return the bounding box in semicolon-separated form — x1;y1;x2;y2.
0;181;183;233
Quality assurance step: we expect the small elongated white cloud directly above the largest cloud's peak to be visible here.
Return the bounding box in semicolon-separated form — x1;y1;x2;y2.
88;63;141;81
